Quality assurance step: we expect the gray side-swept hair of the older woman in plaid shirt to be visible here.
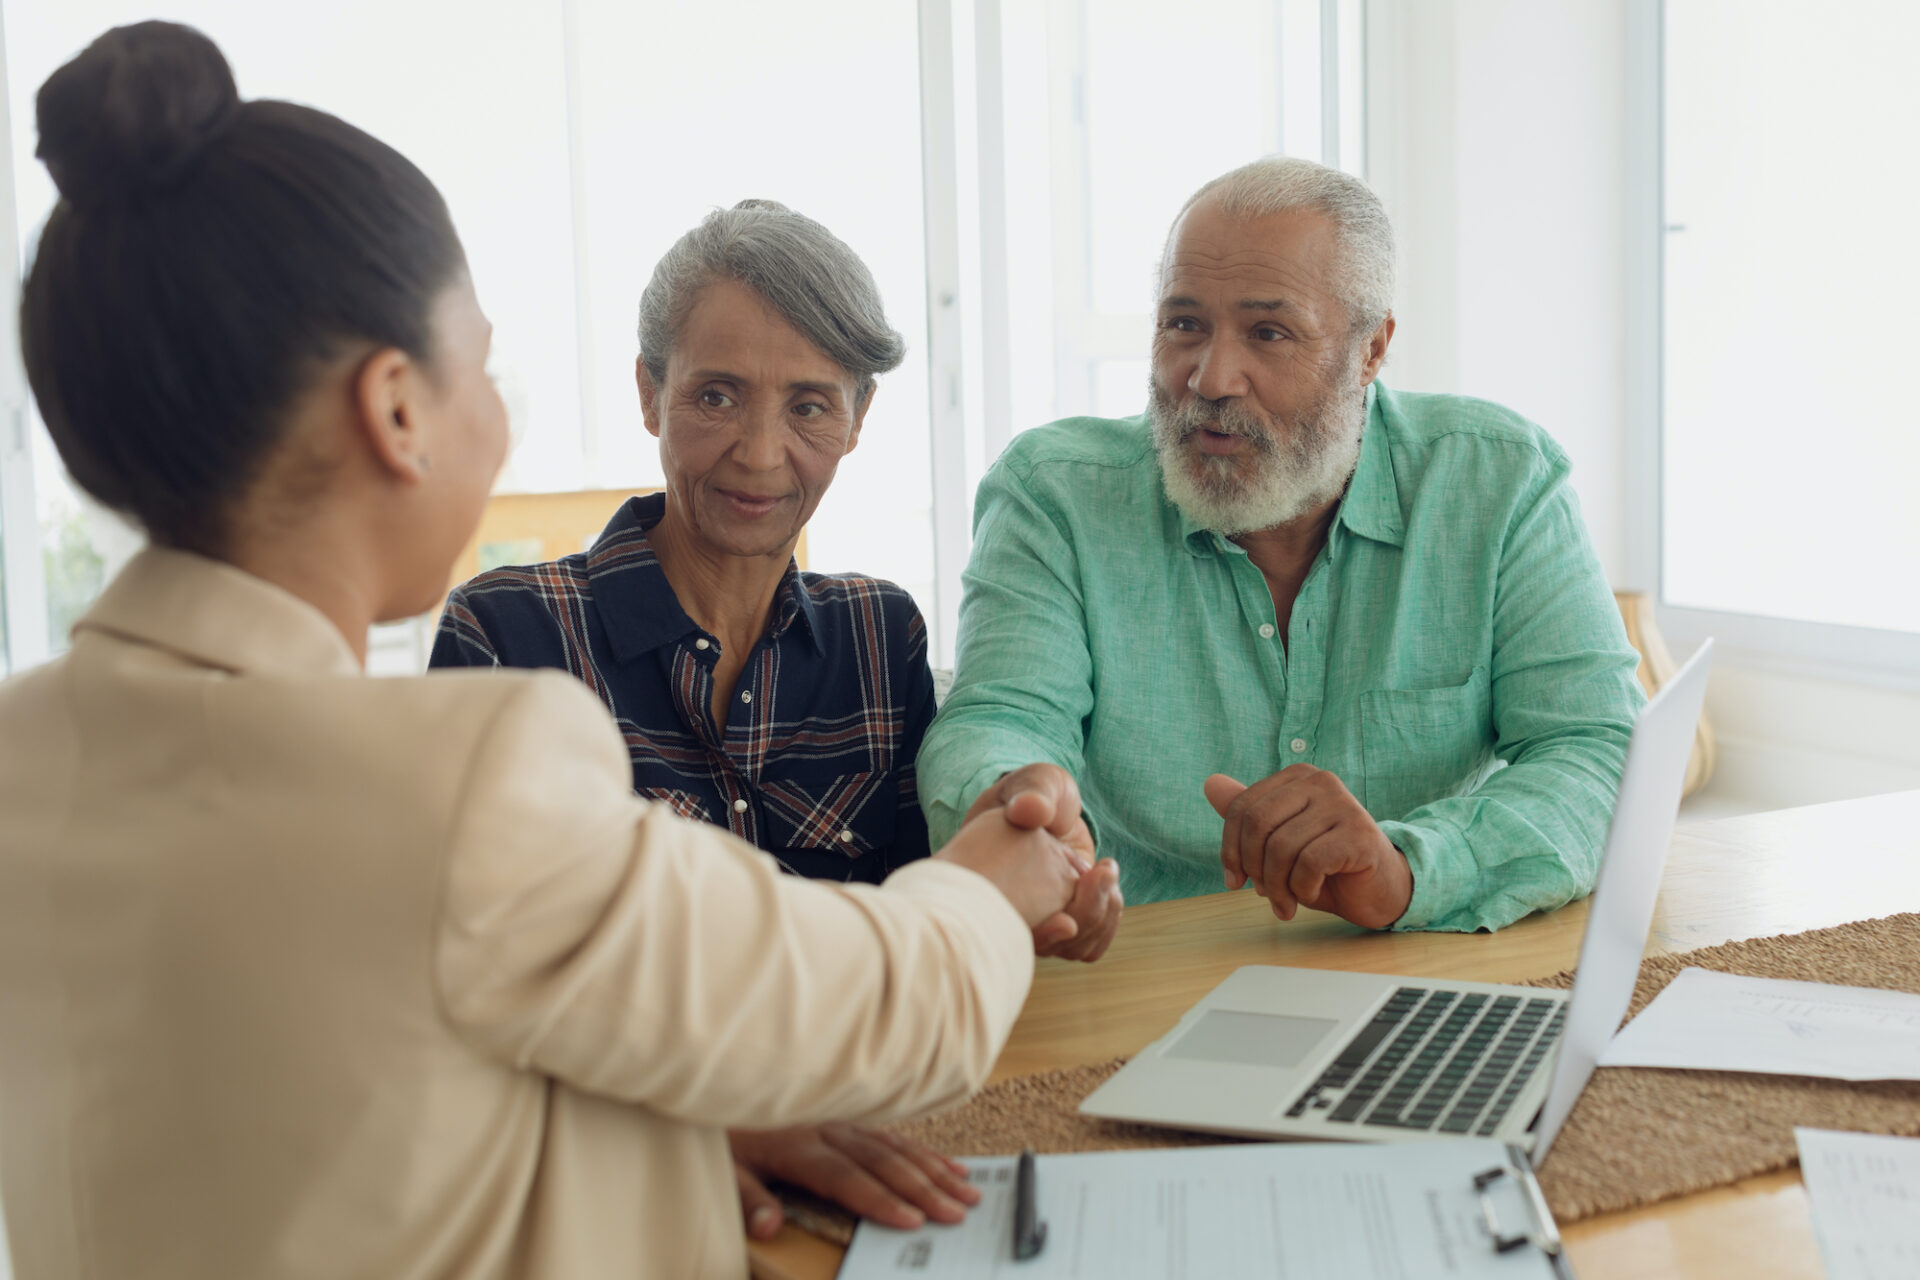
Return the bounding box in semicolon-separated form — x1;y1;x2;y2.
639;200;906;405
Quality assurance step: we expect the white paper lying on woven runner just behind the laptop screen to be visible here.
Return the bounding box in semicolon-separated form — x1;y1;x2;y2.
1599;969;1920;1080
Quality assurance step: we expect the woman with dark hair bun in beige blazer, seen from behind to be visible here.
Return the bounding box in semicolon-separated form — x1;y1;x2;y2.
0;23;1087;1280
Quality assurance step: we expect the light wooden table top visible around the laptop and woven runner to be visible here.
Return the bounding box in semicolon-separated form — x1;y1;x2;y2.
753;791;1920;1280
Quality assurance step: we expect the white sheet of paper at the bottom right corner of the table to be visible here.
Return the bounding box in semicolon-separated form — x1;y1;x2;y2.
1793;1128;1920;1280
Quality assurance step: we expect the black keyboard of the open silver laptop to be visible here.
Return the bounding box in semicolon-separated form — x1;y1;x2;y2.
1286;986;1567;1136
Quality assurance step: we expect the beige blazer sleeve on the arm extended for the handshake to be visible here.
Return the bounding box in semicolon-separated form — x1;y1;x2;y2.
436;674;1033;1126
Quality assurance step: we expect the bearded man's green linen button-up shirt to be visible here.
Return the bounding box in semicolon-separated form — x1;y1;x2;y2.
918;384;1644;931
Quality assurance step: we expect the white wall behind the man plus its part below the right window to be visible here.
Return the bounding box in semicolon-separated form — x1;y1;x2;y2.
1367;0;1920;814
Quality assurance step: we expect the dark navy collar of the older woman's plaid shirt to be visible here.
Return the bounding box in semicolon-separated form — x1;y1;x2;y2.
586;493;826;662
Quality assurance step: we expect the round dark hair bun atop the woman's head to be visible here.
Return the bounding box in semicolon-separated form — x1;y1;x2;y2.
35;21;240;207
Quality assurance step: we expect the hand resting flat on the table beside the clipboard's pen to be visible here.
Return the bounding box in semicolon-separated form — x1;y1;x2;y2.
728;1125;979;1240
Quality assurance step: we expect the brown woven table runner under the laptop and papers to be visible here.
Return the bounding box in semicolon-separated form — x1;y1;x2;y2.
875;915;1920;1222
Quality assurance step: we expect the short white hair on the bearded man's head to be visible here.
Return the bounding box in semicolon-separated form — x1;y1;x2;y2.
1169;155;1394;334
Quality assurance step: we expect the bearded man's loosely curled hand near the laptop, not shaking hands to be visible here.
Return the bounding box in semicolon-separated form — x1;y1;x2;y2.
1206;764;1413;929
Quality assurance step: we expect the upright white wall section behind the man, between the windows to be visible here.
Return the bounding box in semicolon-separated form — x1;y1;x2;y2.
1369;0;1626;581
